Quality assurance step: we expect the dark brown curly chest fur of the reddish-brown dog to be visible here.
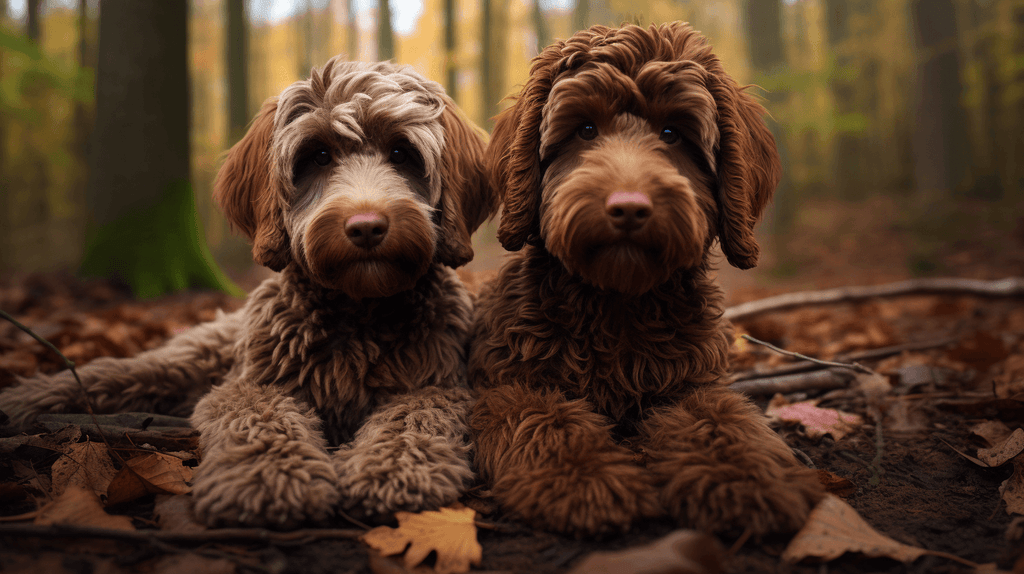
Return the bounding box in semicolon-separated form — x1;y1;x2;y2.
469;247;729;421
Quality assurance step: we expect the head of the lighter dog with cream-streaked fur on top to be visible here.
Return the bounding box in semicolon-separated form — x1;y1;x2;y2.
214;57;497;299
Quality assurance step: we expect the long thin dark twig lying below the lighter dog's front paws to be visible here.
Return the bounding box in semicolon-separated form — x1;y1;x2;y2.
0;524;364;545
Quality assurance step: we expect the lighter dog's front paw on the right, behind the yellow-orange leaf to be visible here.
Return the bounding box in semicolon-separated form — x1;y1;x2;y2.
334;433;473;516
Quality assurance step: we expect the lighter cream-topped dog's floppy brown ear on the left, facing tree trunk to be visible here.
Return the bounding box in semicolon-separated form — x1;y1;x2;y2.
213;99;290;271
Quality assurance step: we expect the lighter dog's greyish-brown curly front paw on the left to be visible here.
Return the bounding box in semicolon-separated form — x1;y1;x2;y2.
193;441;338;528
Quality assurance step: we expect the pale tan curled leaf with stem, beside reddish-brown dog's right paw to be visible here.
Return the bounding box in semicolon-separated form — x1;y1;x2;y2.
782;494;976;567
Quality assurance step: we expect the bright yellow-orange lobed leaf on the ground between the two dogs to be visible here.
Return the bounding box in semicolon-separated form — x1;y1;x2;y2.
359;507;483;574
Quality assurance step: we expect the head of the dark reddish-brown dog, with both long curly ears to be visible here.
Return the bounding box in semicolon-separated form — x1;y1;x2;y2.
487;23;779;294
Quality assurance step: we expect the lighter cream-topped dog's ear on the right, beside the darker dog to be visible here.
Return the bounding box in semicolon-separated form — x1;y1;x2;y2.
437;96;498;268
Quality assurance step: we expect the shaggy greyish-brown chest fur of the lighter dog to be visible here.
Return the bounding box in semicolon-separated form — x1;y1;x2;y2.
236;265;472;443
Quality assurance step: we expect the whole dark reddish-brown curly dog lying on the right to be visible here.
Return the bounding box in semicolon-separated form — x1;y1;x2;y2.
469;23;823;534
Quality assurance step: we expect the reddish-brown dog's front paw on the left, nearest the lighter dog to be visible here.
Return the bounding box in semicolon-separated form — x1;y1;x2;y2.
492;453;664;535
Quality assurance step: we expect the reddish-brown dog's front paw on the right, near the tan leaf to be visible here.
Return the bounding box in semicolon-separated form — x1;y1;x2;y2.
653;454;824;536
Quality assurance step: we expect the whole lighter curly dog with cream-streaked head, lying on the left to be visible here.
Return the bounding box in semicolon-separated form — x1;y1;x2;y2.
0;58;497;526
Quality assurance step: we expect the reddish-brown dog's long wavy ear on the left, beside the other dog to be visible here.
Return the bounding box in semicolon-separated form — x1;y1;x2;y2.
487;50;562;251
